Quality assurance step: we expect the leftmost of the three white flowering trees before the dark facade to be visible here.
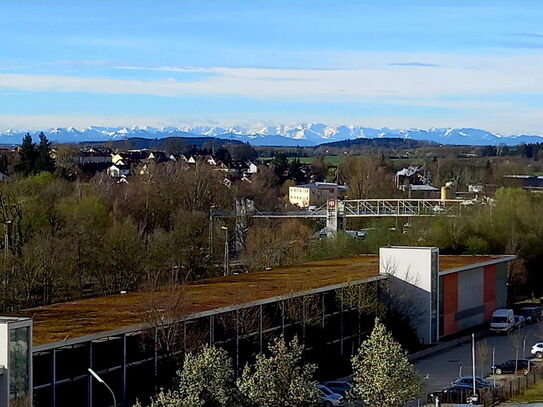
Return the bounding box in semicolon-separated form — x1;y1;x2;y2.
135;346;239;407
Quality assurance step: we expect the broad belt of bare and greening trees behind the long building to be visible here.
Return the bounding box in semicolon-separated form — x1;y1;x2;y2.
0;132;543;310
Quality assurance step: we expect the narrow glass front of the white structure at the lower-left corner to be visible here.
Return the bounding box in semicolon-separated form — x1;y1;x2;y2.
9;327;30;407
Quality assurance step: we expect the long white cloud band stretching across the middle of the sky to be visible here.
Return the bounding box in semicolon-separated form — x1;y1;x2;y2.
0;55;543;103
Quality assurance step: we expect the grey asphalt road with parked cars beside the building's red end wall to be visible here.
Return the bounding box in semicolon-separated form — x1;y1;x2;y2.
414;322;543;392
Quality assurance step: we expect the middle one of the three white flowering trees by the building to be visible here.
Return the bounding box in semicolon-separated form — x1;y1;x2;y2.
237;336;321;407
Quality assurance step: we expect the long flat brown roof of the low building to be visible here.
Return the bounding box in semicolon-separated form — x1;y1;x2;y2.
17;255;511;346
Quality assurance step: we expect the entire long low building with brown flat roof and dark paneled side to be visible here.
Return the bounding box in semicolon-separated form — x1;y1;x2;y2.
0;247;513;407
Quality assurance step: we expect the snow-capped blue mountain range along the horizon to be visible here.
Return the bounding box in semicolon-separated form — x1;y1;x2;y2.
0;123;543;146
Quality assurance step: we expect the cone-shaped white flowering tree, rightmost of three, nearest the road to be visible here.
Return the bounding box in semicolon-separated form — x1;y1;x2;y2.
348;318;422;407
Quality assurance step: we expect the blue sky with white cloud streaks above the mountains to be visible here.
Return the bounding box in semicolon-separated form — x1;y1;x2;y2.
0;0;543;135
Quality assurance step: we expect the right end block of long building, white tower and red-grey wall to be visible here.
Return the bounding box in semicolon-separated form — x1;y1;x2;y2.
379;247;515;343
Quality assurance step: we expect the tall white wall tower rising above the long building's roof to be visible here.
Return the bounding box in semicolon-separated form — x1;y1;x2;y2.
379;247;439;343
